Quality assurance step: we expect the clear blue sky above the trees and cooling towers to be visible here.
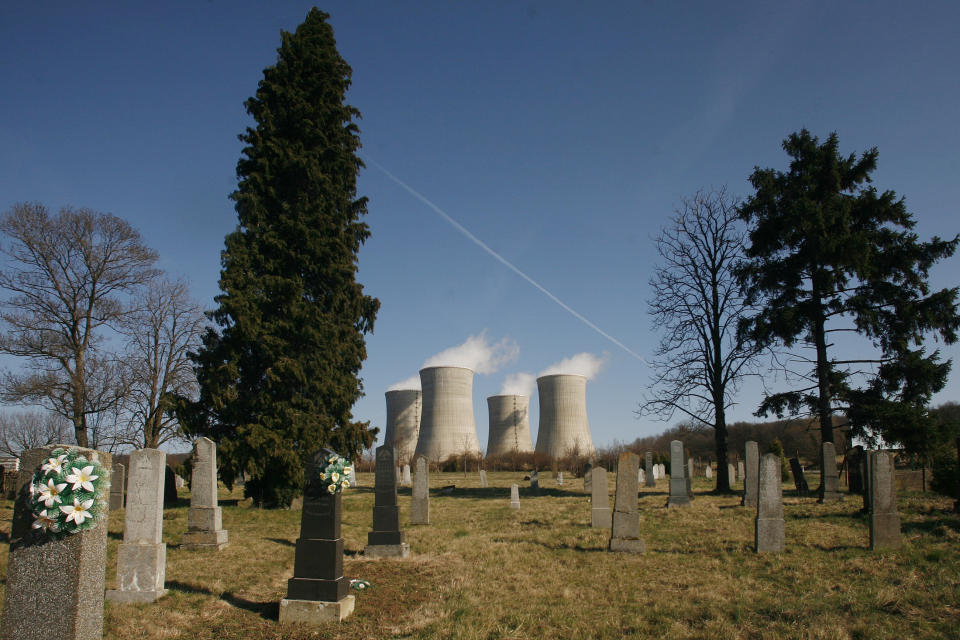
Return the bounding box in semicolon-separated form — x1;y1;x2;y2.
0;0;960;446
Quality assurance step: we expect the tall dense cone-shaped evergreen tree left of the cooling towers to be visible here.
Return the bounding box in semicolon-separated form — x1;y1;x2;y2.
186;8;380;506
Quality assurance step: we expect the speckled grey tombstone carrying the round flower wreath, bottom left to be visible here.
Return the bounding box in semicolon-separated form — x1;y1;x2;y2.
0;445;111;640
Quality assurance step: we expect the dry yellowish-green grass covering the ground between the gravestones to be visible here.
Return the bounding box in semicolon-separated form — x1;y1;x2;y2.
0;473;960;640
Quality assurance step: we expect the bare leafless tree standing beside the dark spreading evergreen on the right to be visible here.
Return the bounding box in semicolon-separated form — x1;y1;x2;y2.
638;188;757;492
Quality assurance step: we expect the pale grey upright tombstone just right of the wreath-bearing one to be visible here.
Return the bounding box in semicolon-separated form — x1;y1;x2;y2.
107;449;167;602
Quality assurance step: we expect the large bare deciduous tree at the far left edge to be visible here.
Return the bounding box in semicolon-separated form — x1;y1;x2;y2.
0;204;157;446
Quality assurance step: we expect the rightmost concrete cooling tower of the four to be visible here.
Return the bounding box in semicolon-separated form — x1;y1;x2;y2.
536;374;594;458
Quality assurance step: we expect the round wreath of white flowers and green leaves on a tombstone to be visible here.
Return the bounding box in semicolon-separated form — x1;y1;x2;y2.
28;449;110;538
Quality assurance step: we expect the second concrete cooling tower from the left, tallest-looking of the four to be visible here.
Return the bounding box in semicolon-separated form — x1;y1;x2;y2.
416;367;480;462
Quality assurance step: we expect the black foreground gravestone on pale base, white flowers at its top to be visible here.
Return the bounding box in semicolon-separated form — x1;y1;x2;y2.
280;450;354;626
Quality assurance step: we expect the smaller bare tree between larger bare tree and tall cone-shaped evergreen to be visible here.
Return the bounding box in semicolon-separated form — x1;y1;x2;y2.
122;279;205;449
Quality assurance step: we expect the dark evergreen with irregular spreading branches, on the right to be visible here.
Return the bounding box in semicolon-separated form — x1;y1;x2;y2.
739;129;960;464
